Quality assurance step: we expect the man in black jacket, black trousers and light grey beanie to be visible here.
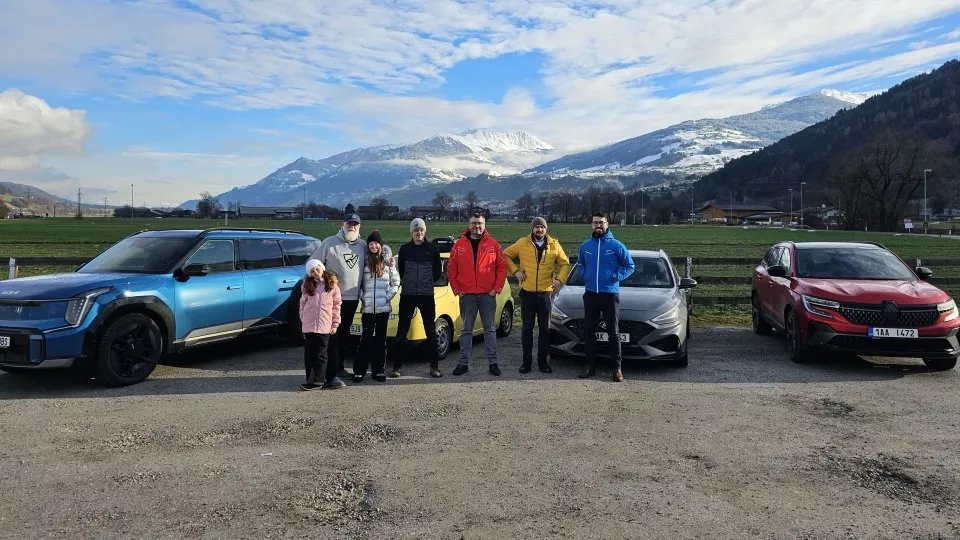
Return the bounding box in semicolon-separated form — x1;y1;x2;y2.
390;218;443;377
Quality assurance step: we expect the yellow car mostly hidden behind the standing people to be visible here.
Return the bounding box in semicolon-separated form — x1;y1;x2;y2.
350;238;513;360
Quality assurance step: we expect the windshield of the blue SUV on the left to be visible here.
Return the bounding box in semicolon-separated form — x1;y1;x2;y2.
77;236;197;274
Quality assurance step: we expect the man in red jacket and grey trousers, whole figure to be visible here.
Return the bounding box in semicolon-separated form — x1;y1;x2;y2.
447;214;507;375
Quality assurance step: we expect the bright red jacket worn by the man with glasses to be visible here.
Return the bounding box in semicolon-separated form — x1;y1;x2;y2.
447;231;507;295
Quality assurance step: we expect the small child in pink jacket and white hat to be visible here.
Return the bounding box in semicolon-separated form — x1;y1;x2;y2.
300;259;346;390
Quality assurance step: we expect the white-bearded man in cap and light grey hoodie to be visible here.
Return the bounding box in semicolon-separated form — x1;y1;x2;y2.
310;214;393;377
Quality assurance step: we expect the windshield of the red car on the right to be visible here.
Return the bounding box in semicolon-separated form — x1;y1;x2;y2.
797;247;916;280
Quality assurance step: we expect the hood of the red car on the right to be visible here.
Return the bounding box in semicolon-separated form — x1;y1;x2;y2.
798;279;950;305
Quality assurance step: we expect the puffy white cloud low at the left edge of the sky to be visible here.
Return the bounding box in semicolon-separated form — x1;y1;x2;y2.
0;89;90;170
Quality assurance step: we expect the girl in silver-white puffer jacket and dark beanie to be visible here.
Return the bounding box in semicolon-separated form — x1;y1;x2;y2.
353;230;400;382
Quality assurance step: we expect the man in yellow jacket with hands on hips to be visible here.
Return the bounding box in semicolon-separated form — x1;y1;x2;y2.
503;217;570;373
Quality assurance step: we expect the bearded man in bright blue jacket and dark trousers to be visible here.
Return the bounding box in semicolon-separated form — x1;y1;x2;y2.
577;212;633;382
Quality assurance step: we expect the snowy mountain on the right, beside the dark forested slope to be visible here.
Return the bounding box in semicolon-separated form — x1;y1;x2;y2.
523;90;872;178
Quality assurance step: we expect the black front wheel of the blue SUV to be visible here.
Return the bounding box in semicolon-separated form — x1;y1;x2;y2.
93;313;163;386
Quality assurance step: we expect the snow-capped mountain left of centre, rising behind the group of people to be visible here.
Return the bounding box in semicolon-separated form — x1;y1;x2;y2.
208;129;556;205
